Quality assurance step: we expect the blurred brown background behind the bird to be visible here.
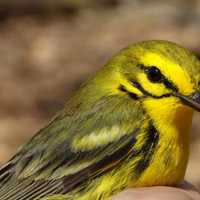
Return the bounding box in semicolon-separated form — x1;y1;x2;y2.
0;0;200;188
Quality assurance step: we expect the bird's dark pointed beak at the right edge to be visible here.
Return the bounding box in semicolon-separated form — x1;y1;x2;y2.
175;92;200;112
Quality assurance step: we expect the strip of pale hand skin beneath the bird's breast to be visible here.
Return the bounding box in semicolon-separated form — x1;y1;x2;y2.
112;182;200;200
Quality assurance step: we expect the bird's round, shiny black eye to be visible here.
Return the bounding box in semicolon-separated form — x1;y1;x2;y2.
145;66;163;83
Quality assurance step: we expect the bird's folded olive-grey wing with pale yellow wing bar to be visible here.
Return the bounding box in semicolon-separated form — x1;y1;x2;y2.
0;94;143;200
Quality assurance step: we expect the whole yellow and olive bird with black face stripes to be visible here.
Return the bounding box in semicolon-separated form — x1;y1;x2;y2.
0;41;200;200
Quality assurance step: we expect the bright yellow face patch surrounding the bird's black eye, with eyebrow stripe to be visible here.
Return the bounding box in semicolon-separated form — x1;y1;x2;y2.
137;52;195;96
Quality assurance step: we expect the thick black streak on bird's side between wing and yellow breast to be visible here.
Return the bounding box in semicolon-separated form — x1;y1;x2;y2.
136;123;159;176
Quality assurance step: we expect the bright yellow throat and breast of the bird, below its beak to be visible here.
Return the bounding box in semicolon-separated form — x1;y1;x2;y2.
133;97;193;187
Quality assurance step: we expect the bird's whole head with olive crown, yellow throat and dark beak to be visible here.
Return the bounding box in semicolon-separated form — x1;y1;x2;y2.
94;41;200;134
